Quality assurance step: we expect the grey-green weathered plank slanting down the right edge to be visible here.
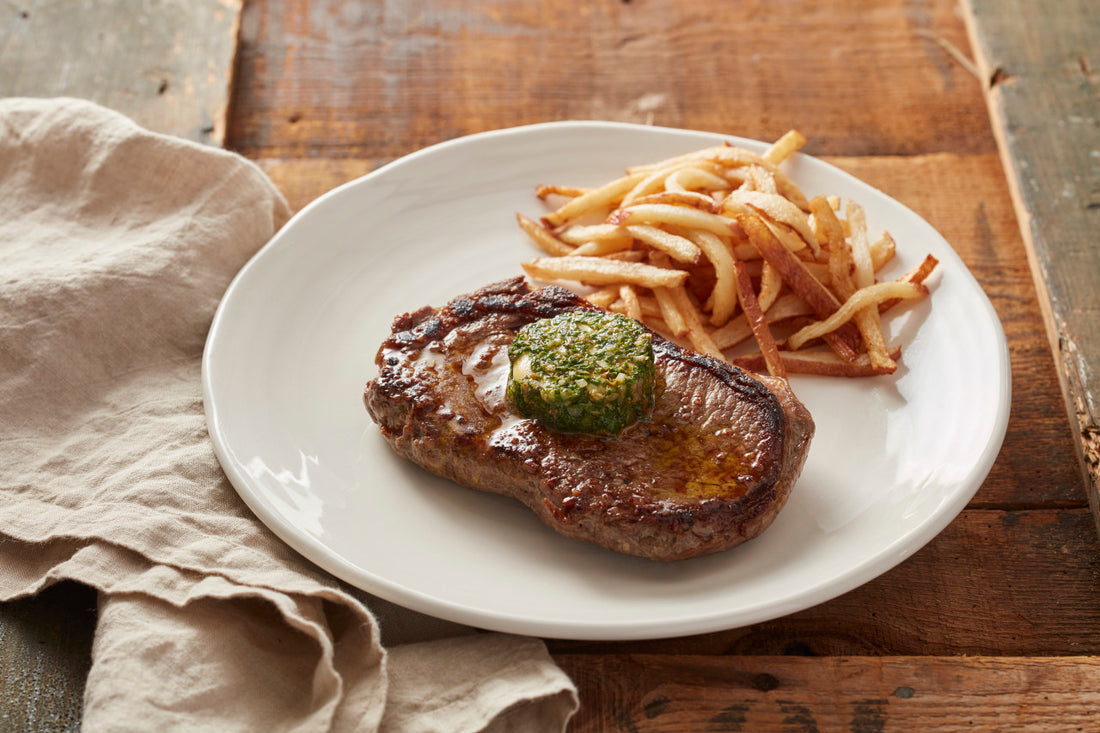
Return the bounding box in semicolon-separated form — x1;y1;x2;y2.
964;0;1100;529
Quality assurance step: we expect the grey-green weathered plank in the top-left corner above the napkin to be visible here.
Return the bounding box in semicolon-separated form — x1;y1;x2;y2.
0;0;243;145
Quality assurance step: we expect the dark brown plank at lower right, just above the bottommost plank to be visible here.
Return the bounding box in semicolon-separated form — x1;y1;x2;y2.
550;505;1100;657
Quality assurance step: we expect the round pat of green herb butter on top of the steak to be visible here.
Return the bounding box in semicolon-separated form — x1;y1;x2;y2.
507;310;653;435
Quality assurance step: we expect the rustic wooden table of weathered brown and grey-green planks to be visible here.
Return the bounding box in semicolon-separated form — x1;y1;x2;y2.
0;0;1100;731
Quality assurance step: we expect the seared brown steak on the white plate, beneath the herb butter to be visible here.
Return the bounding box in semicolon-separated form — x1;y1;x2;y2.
364;277;814;560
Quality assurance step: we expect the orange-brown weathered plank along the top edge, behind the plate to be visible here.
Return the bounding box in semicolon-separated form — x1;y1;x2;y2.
229;0;993;160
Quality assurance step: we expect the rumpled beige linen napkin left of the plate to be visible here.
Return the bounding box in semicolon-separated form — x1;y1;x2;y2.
0;99;578;732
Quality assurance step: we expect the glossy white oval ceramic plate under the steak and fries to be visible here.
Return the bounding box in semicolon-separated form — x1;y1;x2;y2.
202;122;1010;639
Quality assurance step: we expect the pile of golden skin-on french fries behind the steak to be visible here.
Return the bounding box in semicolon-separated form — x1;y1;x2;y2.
516;130;938;379
